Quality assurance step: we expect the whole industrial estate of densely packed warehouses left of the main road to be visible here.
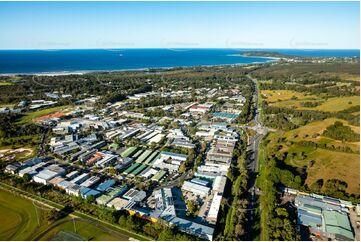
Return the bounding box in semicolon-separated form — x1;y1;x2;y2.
2;85;250;240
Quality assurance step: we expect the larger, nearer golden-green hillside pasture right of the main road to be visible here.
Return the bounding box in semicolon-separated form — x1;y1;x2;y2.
267;118;360;193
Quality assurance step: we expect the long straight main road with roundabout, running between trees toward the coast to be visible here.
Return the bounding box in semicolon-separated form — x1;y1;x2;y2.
242;75;268;240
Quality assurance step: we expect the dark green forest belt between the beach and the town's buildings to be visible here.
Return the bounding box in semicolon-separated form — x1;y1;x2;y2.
0;66;247;104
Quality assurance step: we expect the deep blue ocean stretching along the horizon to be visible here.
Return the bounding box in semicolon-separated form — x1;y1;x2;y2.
0;49;360;74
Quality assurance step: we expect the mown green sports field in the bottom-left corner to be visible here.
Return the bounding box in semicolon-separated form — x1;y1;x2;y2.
0;189;128;240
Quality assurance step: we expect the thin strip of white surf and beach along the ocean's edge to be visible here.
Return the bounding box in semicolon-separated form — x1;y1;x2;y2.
0;58;280;76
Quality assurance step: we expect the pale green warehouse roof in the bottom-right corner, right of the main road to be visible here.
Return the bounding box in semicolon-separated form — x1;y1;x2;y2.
322;210;354;240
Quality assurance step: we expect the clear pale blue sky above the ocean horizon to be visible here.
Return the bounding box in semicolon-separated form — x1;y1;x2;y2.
0;2;360;49
